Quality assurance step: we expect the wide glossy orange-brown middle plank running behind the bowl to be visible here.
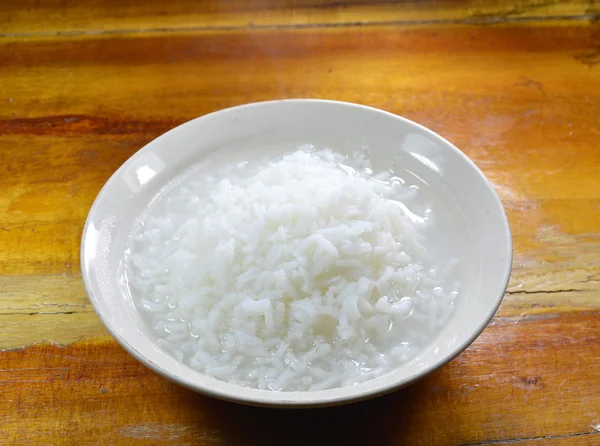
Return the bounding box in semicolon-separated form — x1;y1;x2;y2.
0;25;600;348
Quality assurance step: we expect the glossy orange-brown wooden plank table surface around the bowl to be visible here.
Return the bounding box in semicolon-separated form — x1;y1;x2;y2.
0;0;600;446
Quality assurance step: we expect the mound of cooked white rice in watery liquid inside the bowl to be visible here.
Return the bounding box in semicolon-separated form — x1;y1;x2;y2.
127;150;458;391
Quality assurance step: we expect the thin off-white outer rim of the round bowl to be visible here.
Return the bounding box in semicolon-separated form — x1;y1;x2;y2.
80;98;513;408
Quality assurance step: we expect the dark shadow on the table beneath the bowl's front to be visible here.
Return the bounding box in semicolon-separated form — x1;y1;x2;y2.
178;368;450;446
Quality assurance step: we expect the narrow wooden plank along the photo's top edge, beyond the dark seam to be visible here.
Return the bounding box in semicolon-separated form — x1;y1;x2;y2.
0;0;596;35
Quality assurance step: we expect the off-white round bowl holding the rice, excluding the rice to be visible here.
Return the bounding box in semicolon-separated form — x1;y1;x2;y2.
81;99;512;407
